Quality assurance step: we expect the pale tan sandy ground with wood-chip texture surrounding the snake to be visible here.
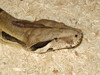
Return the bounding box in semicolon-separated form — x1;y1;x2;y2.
0;0;100;75
